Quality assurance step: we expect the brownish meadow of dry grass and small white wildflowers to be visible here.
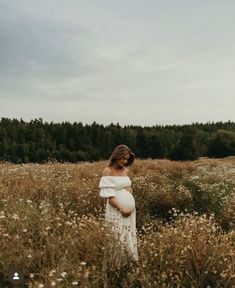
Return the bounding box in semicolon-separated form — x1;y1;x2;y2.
0;157;235;288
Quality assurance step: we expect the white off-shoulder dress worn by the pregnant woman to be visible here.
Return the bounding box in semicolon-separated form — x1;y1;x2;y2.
99;176;138;261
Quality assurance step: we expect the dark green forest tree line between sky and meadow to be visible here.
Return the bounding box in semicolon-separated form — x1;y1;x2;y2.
0;118;235;163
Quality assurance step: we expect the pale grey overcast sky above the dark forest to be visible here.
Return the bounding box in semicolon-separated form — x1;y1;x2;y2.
0;0;235;125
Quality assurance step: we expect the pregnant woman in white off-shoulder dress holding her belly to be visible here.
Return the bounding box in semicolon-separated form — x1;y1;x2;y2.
99;144;138;261
